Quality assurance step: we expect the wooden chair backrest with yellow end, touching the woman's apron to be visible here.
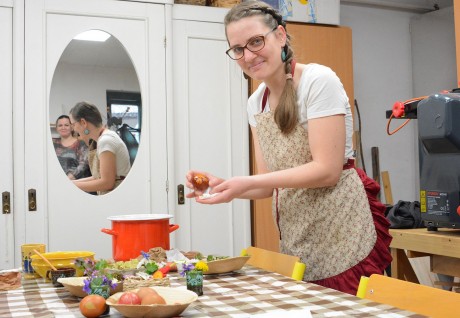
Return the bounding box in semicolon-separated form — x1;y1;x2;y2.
241;246;305;280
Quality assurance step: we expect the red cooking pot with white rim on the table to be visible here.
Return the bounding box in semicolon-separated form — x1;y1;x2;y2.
101;214;179;262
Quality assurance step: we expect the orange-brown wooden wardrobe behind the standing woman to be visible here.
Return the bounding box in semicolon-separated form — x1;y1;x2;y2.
249;22;354;251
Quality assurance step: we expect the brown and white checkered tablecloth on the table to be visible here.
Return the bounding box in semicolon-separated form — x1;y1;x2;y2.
0;266;422;318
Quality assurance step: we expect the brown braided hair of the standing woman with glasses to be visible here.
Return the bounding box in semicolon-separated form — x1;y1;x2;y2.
224;0;299;135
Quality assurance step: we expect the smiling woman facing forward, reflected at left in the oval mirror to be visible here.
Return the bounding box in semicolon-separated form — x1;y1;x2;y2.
53;115;91;180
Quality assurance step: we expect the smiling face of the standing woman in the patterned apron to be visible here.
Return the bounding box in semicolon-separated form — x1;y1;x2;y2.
226;16;286;80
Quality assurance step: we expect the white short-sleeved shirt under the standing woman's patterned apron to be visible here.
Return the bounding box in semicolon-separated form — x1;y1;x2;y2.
247;64;353;162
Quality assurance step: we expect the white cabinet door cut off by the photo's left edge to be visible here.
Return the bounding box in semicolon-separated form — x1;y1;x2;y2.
0;0;15;269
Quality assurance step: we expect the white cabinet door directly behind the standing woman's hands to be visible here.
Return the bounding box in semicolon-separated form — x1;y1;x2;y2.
172;5;251;256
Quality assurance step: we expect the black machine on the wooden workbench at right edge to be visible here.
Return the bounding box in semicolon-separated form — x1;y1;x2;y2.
415;93;460;230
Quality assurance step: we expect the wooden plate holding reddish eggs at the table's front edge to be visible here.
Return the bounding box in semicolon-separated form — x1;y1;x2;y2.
106;287;198;318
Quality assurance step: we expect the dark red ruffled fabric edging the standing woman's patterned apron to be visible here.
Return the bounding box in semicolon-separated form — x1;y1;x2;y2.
312;168;392;295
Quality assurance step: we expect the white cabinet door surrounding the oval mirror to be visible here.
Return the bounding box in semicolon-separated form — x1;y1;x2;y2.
24;0;168;258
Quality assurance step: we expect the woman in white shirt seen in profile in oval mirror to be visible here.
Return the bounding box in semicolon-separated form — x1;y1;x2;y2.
70;102;131;194
